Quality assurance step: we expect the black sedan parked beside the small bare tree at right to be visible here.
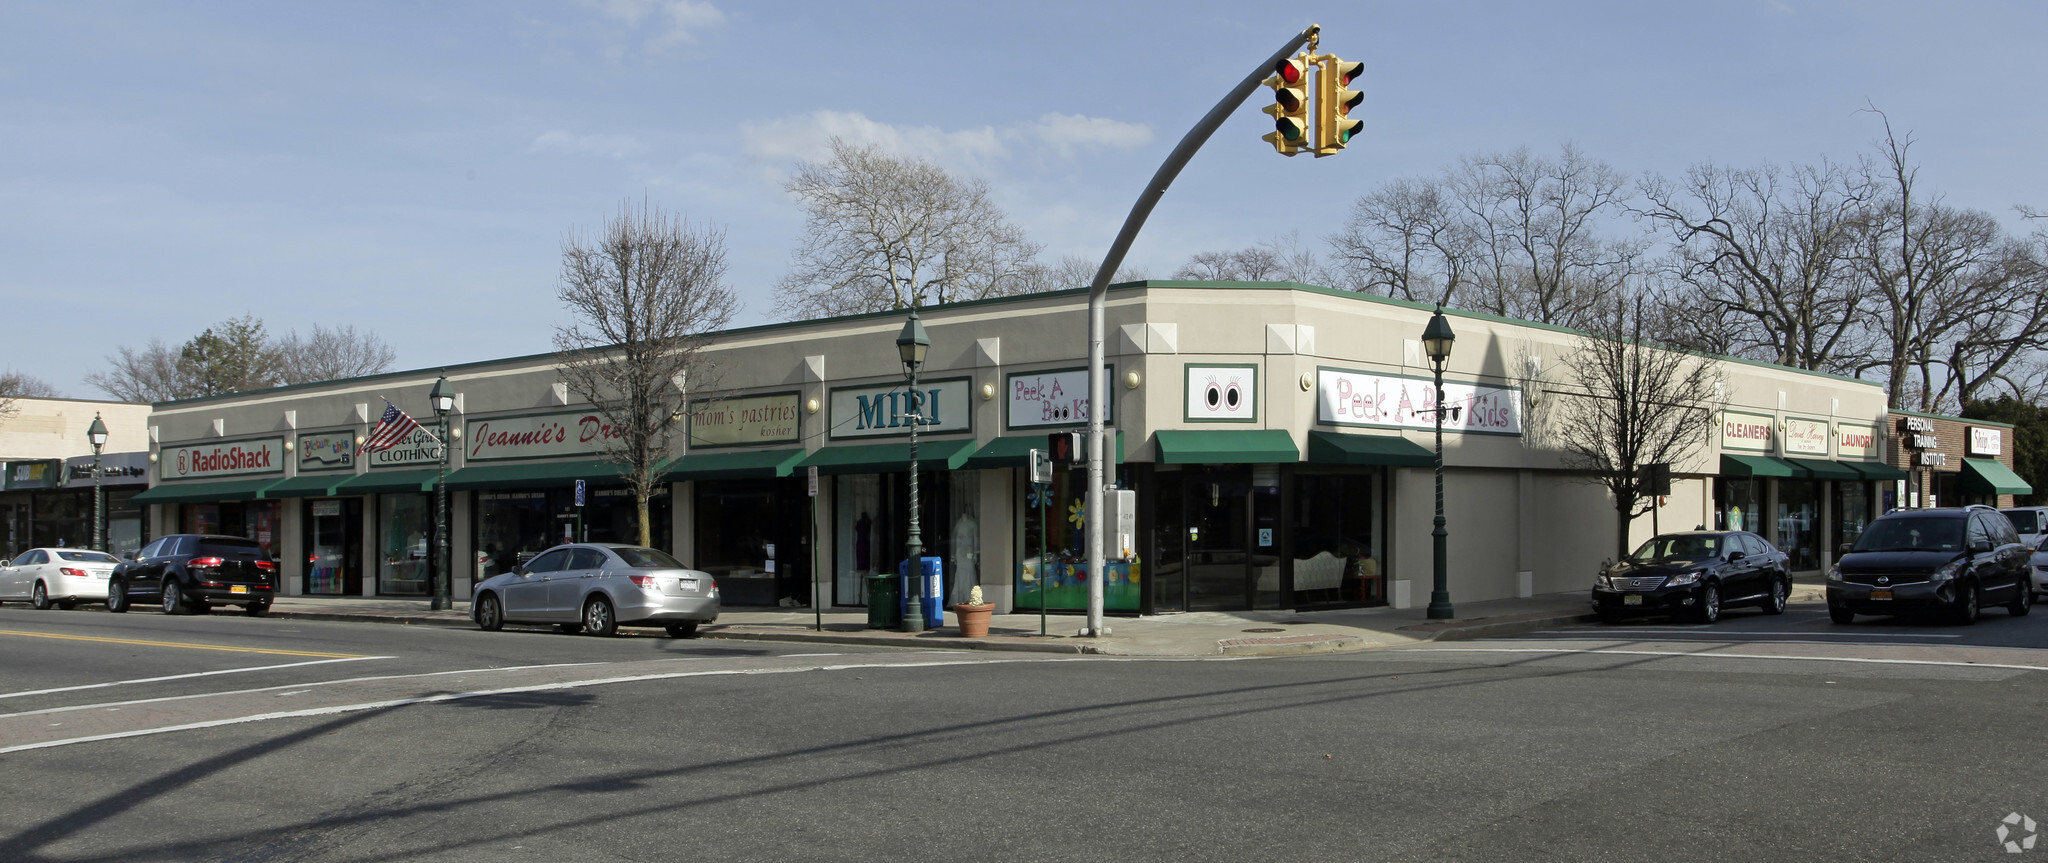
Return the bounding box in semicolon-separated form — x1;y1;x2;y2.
1593;531;1792;623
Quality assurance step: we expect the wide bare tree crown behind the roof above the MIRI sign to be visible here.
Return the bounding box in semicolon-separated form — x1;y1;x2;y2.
776;137;1042;318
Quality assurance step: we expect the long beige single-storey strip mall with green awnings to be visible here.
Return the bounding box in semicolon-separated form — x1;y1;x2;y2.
135;281;2023;613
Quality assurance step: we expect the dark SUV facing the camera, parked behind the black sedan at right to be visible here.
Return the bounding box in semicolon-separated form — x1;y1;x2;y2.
1827;504;2034;623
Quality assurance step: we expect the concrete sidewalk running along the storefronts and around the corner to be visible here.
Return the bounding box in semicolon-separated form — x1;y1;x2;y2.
251;584;1821;656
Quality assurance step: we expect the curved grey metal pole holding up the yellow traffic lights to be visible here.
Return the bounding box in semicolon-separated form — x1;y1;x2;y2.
1081;25;1323;638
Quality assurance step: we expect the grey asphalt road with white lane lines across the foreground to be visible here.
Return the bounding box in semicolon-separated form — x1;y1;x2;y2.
0;607;2048;861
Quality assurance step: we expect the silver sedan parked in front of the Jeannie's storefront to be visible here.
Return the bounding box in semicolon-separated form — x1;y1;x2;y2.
469;543;719;638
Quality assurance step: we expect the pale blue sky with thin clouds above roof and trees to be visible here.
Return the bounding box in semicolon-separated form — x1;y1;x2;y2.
0;0;2048;398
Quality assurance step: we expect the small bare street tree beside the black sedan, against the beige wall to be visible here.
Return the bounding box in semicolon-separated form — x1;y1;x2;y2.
1548;297;1722;560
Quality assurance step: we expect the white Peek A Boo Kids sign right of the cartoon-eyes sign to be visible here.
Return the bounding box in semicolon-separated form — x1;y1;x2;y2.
1315;369;1522;435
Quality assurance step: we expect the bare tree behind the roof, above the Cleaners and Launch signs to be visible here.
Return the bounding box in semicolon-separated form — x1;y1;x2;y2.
1636;160;1872;373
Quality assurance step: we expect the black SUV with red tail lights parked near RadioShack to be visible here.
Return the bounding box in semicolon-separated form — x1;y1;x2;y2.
106;533;276;617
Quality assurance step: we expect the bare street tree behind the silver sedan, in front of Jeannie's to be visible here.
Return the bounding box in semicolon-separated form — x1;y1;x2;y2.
555;201;739;545
